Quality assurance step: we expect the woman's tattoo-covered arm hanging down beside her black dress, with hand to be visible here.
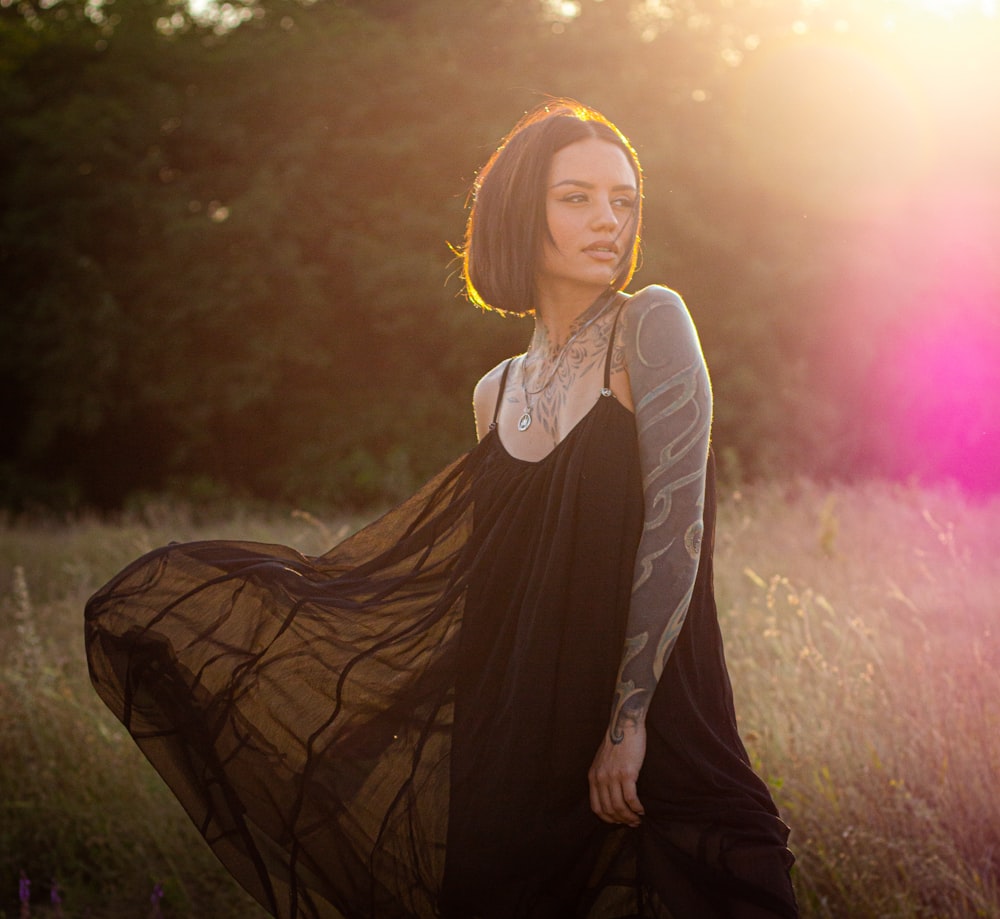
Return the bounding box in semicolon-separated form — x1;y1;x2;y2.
590;288;712;825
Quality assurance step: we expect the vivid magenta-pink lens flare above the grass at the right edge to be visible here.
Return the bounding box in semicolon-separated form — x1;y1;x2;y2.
841;187;1000;491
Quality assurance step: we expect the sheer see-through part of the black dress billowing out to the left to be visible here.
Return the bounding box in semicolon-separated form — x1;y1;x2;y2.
86;455;480;917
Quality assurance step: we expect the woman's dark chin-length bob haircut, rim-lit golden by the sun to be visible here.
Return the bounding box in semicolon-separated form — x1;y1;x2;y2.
459;99;642;316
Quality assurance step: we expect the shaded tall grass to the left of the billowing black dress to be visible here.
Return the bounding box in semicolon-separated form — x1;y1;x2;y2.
0;504;356;919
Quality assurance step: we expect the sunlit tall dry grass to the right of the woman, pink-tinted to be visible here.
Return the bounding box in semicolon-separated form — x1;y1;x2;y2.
717;483;1000;919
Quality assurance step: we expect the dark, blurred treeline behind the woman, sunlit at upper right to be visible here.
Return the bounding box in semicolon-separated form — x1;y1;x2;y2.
0;0;1000;508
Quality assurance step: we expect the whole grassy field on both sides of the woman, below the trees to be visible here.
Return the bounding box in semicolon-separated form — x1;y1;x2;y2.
0;482;1000;919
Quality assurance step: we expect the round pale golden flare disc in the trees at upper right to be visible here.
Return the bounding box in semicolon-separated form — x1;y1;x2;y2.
741;36;939;216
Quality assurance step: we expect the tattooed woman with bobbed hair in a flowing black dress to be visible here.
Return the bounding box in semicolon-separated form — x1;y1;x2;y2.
87;102;795;919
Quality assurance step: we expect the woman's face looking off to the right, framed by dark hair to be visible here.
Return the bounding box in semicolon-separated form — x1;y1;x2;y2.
537;137;638;296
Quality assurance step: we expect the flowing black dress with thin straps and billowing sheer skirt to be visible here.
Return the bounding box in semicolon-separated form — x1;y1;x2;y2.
86;320;794;919
